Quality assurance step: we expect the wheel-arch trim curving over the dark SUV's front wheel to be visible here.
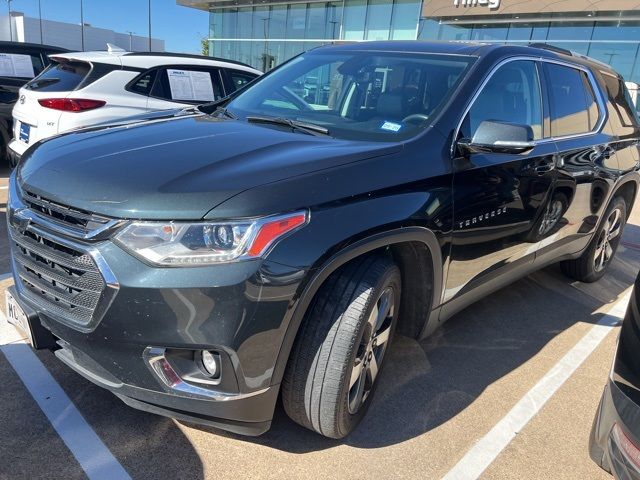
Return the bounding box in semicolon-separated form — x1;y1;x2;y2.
271;227;443;385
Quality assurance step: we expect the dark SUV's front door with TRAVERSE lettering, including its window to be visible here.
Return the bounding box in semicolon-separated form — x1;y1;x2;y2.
444;60;556;301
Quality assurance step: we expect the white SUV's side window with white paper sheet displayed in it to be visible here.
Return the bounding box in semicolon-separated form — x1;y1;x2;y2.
151;66;223;103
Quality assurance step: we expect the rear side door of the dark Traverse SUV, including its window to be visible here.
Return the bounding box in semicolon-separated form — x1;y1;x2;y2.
536;62;617;263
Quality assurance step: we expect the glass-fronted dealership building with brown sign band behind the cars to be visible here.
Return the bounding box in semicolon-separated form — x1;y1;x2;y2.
177;0;640;83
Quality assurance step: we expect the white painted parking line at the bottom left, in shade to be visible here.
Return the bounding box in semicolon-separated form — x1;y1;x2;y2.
0;311;131;480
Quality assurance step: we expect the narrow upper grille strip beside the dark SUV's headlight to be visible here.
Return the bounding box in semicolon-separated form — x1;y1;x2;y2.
22;191;112;234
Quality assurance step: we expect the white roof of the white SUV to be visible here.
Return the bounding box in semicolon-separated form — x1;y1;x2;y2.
50;50;260;73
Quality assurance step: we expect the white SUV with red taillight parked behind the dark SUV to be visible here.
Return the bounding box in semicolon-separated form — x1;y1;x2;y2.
8;47;261;165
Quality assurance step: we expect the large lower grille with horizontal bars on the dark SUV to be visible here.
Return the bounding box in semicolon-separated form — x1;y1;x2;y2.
10;227;107;326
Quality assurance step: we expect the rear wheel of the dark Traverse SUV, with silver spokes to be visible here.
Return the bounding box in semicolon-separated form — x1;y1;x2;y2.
560;197;627;283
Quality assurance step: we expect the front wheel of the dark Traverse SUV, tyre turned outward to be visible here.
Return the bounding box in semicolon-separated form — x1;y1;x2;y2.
282;256;401;438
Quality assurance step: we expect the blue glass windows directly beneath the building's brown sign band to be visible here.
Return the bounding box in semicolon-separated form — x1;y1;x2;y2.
418;16;640;83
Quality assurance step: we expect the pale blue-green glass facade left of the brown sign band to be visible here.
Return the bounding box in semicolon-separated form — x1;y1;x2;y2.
209;0;422;71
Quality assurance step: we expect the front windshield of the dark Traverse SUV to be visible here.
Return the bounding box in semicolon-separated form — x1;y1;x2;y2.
227;50;474;141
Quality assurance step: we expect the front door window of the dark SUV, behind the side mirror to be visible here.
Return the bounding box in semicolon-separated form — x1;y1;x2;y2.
461;60;542;140
